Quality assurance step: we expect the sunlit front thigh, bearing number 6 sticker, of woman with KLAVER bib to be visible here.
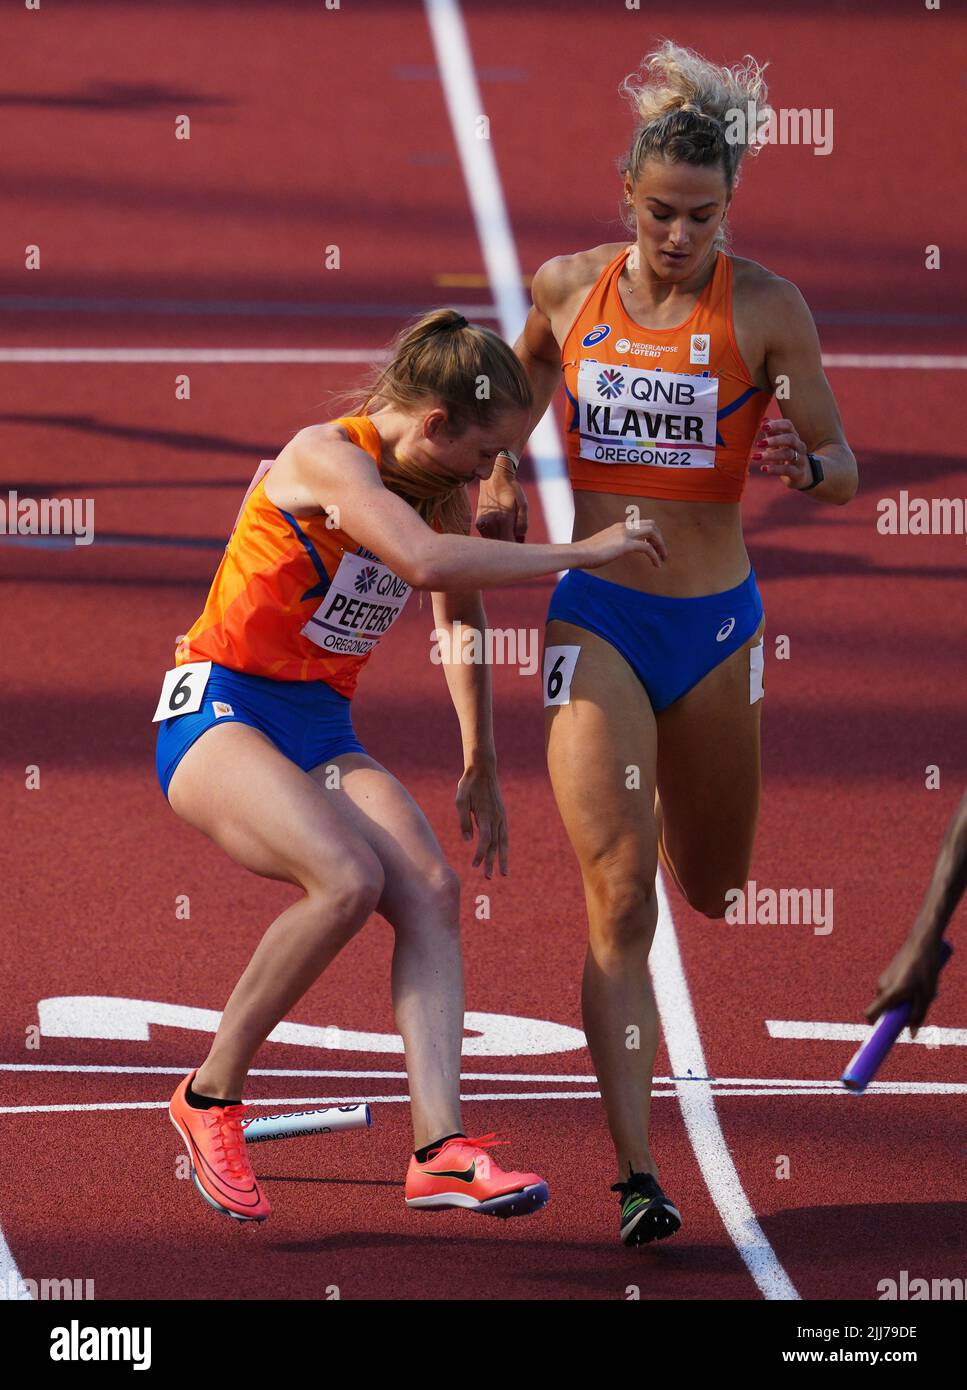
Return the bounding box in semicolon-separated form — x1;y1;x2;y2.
545;620;656;877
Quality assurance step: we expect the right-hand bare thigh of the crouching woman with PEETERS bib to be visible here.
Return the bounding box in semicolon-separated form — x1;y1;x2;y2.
310;753;449;922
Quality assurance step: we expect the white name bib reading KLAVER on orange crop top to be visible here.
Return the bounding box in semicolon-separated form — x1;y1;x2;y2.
578;360;718;468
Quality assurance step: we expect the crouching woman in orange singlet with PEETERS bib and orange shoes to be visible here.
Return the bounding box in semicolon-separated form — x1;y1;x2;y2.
156;310;664;1220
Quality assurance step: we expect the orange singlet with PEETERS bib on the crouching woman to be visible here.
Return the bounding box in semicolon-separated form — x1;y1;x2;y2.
175;416;410;696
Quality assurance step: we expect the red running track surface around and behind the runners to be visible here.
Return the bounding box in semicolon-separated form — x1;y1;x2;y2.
0;3;967;1298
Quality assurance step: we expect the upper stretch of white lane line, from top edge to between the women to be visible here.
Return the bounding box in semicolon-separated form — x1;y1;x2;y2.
424;0;574;543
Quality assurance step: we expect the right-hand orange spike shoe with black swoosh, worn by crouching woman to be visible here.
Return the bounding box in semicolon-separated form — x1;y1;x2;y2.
406;1134;549;1216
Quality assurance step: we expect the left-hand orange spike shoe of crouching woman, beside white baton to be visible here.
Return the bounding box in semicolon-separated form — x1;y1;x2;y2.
168;1072;272;1220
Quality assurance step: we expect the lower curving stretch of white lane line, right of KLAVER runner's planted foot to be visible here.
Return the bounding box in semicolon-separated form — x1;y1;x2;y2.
649;872;799;1300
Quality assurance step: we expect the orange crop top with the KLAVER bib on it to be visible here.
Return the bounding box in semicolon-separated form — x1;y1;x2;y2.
561;246;770;502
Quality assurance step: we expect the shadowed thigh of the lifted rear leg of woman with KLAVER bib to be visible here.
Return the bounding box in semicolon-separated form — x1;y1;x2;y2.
657;626;763;878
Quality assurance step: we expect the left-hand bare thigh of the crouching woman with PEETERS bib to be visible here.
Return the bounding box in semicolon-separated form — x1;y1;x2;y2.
168;721;378;887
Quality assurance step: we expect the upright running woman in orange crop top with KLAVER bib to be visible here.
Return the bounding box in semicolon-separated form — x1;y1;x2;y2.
478;42;857;1244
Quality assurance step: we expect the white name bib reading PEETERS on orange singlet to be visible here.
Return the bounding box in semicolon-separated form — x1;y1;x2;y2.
301;553;411;656
